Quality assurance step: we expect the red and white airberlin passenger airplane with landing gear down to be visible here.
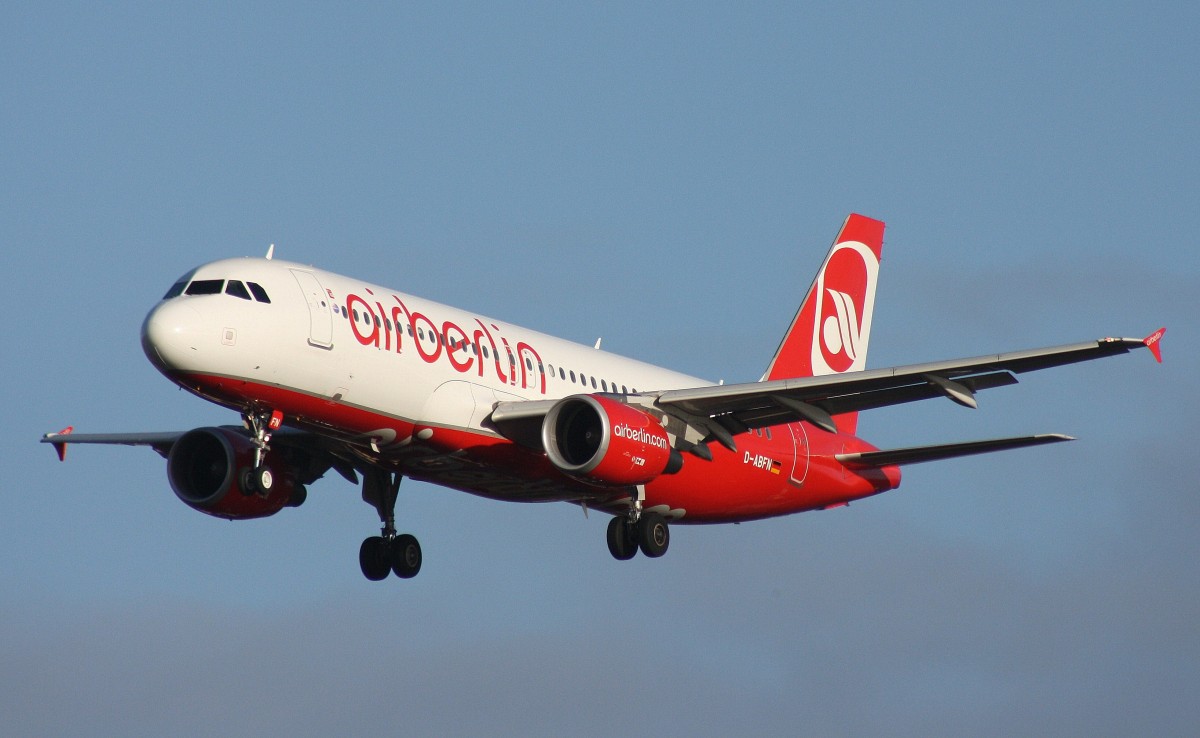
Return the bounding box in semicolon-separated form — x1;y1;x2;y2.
42;214;1165;581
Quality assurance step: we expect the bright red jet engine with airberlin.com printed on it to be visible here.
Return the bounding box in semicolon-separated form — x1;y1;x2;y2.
541;395;683;486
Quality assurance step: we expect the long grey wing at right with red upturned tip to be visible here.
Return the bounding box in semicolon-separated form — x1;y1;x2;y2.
491;329;1164;460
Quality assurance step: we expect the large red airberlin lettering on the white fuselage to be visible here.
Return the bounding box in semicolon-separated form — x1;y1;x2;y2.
343;289;546;395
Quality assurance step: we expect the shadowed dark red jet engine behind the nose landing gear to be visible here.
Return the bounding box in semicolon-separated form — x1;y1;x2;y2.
167;428;305;520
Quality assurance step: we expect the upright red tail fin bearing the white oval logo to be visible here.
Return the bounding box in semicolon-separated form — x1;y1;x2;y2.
763;214;883;433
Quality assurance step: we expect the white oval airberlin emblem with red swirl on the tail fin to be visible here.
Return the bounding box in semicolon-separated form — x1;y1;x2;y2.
812;241;880;376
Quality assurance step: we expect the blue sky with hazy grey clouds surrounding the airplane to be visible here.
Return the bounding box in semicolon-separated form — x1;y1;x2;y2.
0;2;1200;736
